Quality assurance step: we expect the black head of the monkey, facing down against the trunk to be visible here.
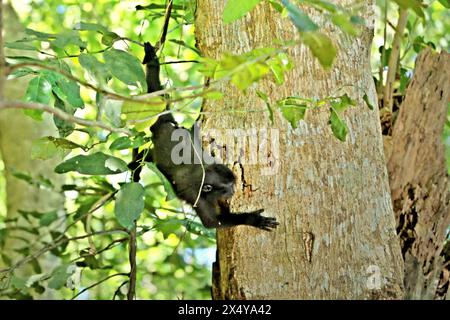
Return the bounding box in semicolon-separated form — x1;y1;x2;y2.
202;164;236;201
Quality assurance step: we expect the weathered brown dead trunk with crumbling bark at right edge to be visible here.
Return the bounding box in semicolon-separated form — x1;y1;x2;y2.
388;49;450;299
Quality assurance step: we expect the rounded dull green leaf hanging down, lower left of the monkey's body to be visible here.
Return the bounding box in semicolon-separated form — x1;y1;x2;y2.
114;182;145;229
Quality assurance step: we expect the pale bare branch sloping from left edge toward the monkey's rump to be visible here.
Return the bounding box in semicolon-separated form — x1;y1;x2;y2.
0;101;132;136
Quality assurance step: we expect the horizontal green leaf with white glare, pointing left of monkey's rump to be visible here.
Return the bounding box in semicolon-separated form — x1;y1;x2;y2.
55;152;128;175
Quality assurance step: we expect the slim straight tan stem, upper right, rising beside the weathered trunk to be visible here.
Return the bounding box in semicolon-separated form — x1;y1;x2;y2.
383;8;408;112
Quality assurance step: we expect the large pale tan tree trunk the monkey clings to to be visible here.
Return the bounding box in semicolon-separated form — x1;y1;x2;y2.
196;0;403;299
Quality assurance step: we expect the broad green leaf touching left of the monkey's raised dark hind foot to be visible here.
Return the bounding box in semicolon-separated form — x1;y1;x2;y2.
103;49;147;92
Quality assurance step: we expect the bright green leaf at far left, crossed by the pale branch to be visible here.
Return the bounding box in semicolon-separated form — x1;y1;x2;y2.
25;76;52;120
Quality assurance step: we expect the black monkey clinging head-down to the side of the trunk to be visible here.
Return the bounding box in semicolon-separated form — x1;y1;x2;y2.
130;43;278;231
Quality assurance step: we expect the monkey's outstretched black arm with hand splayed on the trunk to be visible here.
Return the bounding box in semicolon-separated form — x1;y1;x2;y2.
195;199;279;231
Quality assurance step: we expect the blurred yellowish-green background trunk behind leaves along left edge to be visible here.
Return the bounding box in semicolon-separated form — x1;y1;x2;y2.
0;4;64;273
